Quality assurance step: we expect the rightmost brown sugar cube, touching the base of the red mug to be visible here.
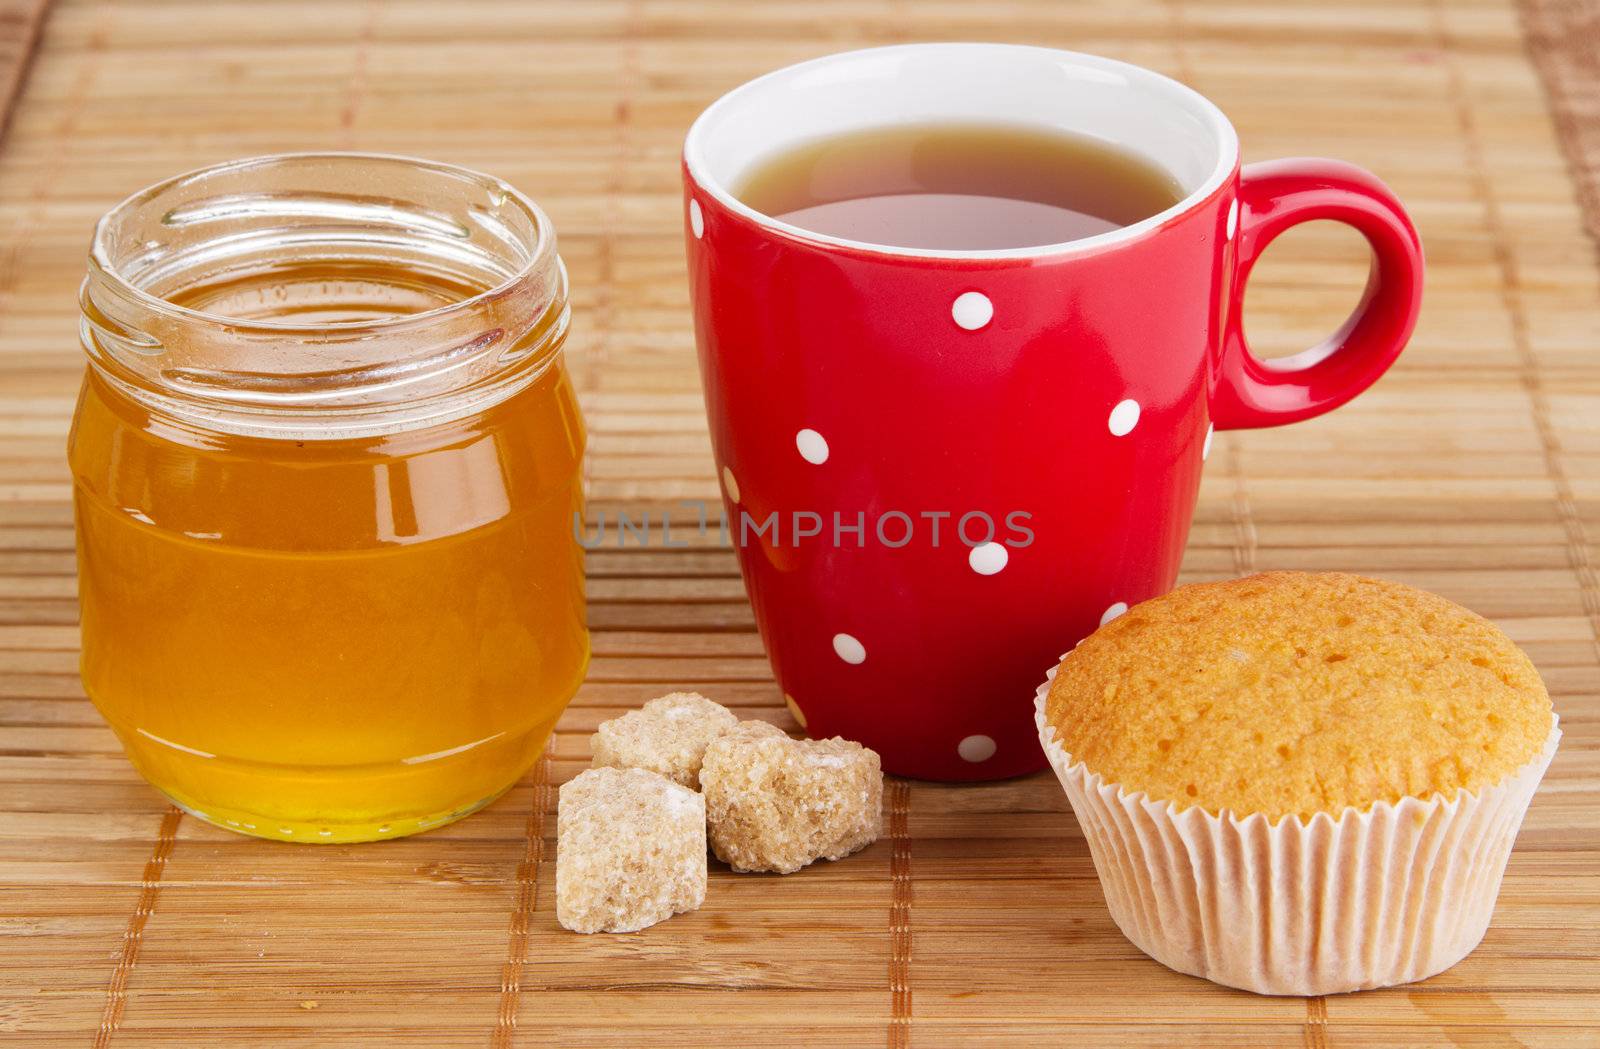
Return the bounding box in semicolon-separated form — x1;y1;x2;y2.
701;721;883;875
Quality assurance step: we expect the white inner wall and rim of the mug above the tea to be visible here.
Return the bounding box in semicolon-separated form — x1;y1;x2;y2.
683;43;1238;257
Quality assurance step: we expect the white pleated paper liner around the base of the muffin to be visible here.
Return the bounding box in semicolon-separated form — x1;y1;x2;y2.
1034;658;1562;995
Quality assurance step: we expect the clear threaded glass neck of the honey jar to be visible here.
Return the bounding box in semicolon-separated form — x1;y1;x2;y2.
78;152;571;437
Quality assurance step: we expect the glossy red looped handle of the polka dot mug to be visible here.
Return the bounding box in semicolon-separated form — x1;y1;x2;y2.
1211;158;1422;430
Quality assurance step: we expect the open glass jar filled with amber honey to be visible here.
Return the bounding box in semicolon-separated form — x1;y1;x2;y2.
69;154;589;843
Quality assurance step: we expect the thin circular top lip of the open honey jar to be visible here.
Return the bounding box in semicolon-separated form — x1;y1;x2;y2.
90;150;555;334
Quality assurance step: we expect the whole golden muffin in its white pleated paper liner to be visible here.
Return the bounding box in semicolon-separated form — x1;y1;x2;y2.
1037;572;1560;995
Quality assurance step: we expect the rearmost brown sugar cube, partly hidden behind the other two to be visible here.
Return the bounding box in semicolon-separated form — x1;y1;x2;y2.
589;692;739;790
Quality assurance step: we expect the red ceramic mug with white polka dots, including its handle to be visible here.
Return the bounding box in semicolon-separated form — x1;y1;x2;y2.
683;43;1422;780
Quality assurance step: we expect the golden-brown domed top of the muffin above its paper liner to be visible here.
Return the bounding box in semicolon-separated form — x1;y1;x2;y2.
1045;572;1552;820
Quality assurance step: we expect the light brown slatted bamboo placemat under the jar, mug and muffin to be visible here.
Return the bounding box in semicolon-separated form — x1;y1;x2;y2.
0;0;1600;1049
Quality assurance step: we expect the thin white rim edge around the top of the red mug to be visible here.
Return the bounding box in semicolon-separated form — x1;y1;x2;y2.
683;42;1238;262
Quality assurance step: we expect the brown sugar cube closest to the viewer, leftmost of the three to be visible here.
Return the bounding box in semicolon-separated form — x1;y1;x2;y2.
555;768;706;932
